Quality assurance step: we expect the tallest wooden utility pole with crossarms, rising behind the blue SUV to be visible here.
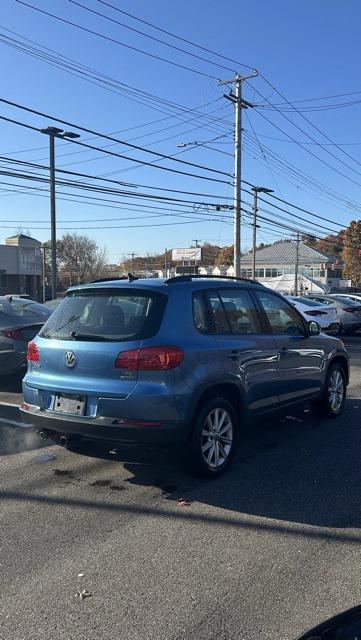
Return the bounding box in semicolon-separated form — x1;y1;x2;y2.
218;71;258;277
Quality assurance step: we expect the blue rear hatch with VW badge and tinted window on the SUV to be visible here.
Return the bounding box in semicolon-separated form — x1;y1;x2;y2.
26;287;167;415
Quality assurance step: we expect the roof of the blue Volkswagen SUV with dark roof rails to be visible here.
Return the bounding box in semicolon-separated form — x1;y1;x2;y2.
68;276;264;293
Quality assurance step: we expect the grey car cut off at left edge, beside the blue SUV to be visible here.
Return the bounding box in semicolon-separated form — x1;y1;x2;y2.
0;296;51;375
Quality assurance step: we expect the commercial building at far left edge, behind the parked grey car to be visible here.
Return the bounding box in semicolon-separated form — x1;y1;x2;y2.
0;233;41;300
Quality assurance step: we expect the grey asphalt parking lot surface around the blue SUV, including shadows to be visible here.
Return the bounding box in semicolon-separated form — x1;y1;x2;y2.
0;335;361;640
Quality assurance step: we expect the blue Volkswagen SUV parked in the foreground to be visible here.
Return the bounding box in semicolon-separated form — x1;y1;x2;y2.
22;275;349;477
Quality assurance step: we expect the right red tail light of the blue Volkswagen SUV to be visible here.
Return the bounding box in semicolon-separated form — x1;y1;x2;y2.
115;347;184;371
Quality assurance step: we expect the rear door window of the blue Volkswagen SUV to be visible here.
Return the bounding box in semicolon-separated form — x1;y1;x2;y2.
219;289;260;335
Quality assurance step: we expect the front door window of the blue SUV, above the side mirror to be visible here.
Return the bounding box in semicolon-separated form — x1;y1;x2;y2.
257;291;305;336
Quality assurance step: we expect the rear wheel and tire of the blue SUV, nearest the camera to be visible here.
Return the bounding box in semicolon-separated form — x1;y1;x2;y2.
188;397;238;478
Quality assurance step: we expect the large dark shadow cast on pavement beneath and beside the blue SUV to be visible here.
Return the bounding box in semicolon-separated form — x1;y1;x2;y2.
56;398;361;528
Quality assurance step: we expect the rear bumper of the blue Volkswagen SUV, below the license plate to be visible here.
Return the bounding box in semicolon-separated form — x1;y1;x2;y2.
20;403;190;445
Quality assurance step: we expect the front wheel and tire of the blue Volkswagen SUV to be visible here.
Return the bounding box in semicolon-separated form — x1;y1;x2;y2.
314;363;346;418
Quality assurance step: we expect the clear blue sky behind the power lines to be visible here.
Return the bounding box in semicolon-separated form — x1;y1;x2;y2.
0;0;361;262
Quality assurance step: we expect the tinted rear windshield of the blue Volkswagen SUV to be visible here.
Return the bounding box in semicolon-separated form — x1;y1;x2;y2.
39;289;167;342
